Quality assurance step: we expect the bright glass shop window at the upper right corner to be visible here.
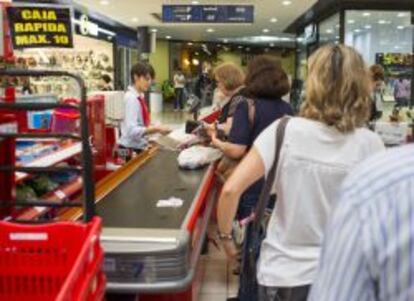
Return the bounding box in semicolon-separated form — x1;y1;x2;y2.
345;10;414;110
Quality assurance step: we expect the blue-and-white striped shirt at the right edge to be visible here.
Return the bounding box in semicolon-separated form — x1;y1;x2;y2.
308;146;414;301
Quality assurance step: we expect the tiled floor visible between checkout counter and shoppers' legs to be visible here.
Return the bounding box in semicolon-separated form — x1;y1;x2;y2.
199;225;238;301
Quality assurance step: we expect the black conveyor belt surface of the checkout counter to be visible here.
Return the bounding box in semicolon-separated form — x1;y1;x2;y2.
96;150;207;229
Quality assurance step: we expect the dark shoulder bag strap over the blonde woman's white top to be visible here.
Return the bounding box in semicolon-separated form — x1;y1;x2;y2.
253;116;290;231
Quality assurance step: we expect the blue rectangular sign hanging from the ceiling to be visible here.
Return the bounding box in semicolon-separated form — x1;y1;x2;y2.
162;5;254;23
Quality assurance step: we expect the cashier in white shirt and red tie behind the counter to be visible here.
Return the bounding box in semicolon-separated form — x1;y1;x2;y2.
119;62;170;153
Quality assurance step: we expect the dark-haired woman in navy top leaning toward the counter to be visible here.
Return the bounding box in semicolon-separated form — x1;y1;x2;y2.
212;56;293;300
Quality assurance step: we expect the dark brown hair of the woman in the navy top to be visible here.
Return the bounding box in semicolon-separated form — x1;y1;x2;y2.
245;55;290;100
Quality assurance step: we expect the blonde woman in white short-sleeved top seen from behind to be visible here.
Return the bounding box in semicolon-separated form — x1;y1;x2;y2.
218;45;384;301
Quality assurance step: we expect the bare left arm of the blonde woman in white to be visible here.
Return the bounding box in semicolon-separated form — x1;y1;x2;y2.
217;147;265;257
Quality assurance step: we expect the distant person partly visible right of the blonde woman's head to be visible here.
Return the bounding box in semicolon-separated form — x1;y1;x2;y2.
369;65;384;121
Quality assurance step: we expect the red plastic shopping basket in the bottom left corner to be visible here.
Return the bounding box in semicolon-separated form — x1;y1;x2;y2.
0;217;106;301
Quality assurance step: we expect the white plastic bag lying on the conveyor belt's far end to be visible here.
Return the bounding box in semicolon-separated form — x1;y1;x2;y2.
178;145;222;169
